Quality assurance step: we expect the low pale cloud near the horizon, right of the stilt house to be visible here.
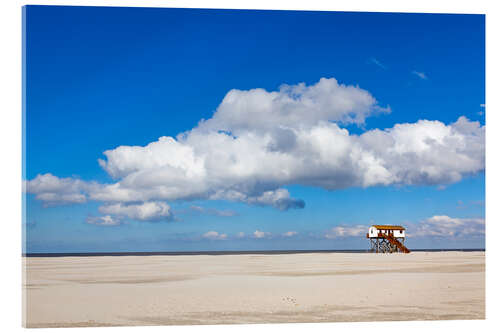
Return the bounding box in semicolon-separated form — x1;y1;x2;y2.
408;215;485;237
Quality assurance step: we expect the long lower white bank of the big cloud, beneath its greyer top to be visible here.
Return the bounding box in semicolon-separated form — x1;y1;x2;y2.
86;117;484;210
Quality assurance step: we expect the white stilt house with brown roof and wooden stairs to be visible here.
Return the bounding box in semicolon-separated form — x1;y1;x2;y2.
366;225;410;253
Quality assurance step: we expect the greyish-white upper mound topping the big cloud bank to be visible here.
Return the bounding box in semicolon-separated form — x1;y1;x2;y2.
198;78;390;132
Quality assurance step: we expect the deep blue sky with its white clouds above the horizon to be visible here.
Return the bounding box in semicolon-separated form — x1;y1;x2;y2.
24;6;485;252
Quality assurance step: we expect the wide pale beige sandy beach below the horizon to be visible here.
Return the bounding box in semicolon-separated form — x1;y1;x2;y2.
23;252;485;327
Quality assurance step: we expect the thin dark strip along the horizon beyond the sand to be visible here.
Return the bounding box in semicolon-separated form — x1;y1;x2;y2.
22;249;485;257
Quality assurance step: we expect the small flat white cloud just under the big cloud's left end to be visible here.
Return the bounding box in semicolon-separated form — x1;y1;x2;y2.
99;201;173;221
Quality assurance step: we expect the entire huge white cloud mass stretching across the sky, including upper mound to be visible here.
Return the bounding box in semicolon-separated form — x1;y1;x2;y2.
25;78;485;220
